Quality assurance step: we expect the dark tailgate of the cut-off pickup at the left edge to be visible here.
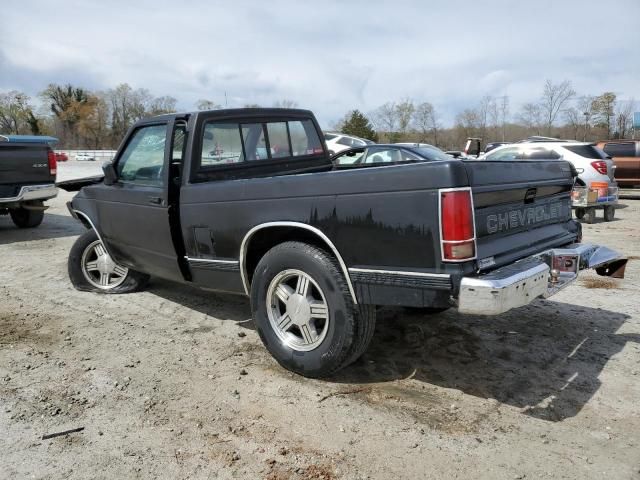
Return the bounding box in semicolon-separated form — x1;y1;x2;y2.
0;142;55;198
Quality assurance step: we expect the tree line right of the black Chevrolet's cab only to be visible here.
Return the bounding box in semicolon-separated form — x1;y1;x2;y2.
334;80;639;149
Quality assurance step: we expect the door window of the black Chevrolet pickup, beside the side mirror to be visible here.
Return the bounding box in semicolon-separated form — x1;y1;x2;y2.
116;125;167;187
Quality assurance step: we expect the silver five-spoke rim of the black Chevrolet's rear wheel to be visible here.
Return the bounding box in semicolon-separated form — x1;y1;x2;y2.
267;270;329;352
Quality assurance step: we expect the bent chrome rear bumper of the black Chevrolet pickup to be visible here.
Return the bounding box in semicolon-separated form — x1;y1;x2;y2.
458;243;627;315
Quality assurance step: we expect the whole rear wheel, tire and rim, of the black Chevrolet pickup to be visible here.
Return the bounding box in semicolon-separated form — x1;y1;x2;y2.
251;242;375;378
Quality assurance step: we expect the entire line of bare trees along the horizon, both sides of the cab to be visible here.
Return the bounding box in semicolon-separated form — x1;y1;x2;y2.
0;80;638;149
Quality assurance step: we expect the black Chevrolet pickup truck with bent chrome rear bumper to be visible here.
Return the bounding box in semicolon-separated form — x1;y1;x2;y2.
60;109;626;377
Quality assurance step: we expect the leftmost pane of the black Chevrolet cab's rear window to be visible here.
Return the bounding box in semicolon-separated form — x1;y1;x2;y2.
201;123;243;167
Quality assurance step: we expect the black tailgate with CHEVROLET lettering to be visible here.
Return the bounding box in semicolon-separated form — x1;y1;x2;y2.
465;160;579;269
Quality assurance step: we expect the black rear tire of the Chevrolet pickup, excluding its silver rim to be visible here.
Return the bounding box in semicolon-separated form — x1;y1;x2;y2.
251;242;375;378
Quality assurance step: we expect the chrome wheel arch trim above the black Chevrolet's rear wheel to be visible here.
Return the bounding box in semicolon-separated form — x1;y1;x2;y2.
240;221;358;304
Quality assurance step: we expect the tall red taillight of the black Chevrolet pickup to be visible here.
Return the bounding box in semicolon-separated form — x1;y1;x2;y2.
440;189;476;262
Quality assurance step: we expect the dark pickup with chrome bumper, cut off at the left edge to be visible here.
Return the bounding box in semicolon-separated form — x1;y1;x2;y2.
0;135;58;228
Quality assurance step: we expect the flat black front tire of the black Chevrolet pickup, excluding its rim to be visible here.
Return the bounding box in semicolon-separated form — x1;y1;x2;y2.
67;229;149;294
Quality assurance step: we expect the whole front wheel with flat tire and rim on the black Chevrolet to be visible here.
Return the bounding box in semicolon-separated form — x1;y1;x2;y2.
67;229;149;293
